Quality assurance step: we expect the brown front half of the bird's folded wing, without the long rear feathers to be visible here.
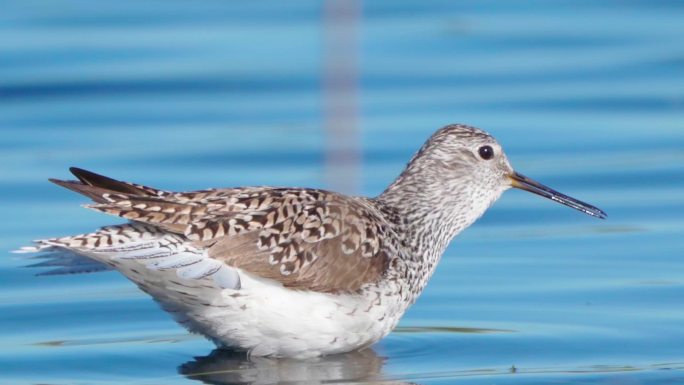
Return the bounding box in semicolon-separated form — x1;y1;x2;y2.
195;190;389;292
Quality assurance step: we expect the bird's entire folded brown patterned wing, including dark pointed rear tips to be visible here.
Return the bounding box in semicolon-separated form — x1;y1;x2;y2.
54;169;390;292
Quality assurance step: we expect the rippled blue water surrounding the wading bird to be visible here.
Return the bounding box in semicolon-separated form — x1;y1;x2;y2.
0;0;684;384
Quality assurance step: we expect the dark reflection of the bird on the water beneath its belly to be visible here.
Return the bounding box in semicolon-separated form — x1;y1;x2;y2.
178;349;414;385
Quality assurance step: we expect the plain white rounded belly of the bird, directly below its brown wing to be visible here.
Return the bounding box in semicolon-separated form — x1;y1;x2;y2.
177;272;401;358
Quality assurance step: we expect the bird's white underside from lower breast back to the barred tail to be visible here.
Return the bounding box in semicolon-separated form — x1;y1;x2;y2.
25;225;408;358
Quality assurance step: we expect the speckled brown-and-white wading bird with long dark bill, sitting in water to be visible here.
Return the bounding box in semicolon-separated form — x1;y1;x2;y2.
18;124;607;359
